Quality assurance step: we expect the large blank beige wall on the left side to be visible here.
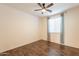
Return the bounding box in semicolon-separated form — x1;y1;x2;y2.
0;5;39;52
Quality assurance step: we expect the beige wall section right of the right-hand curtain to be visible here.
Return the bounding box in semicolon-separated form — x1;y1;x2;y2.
64;7;79;48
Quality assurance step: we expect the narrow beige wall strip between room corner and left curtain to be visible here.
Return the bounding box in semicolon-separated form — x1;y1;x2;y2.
40;17;47;40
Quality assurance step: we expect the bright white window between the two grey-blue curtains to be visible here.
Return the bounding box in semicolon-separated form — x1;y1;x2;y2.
48;15;62;33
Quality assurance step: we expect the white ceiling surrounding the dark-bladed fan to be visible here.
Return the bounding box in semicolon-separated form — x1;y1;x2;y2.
1;3;79;16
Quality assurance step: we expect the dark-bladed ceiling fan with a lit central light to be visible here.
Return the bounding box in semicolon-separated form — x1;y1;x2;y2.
34;3;54;14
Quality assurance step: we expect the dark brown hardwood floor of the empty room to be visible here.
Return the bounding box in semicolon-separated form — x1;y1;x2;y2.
0;40;79;56
